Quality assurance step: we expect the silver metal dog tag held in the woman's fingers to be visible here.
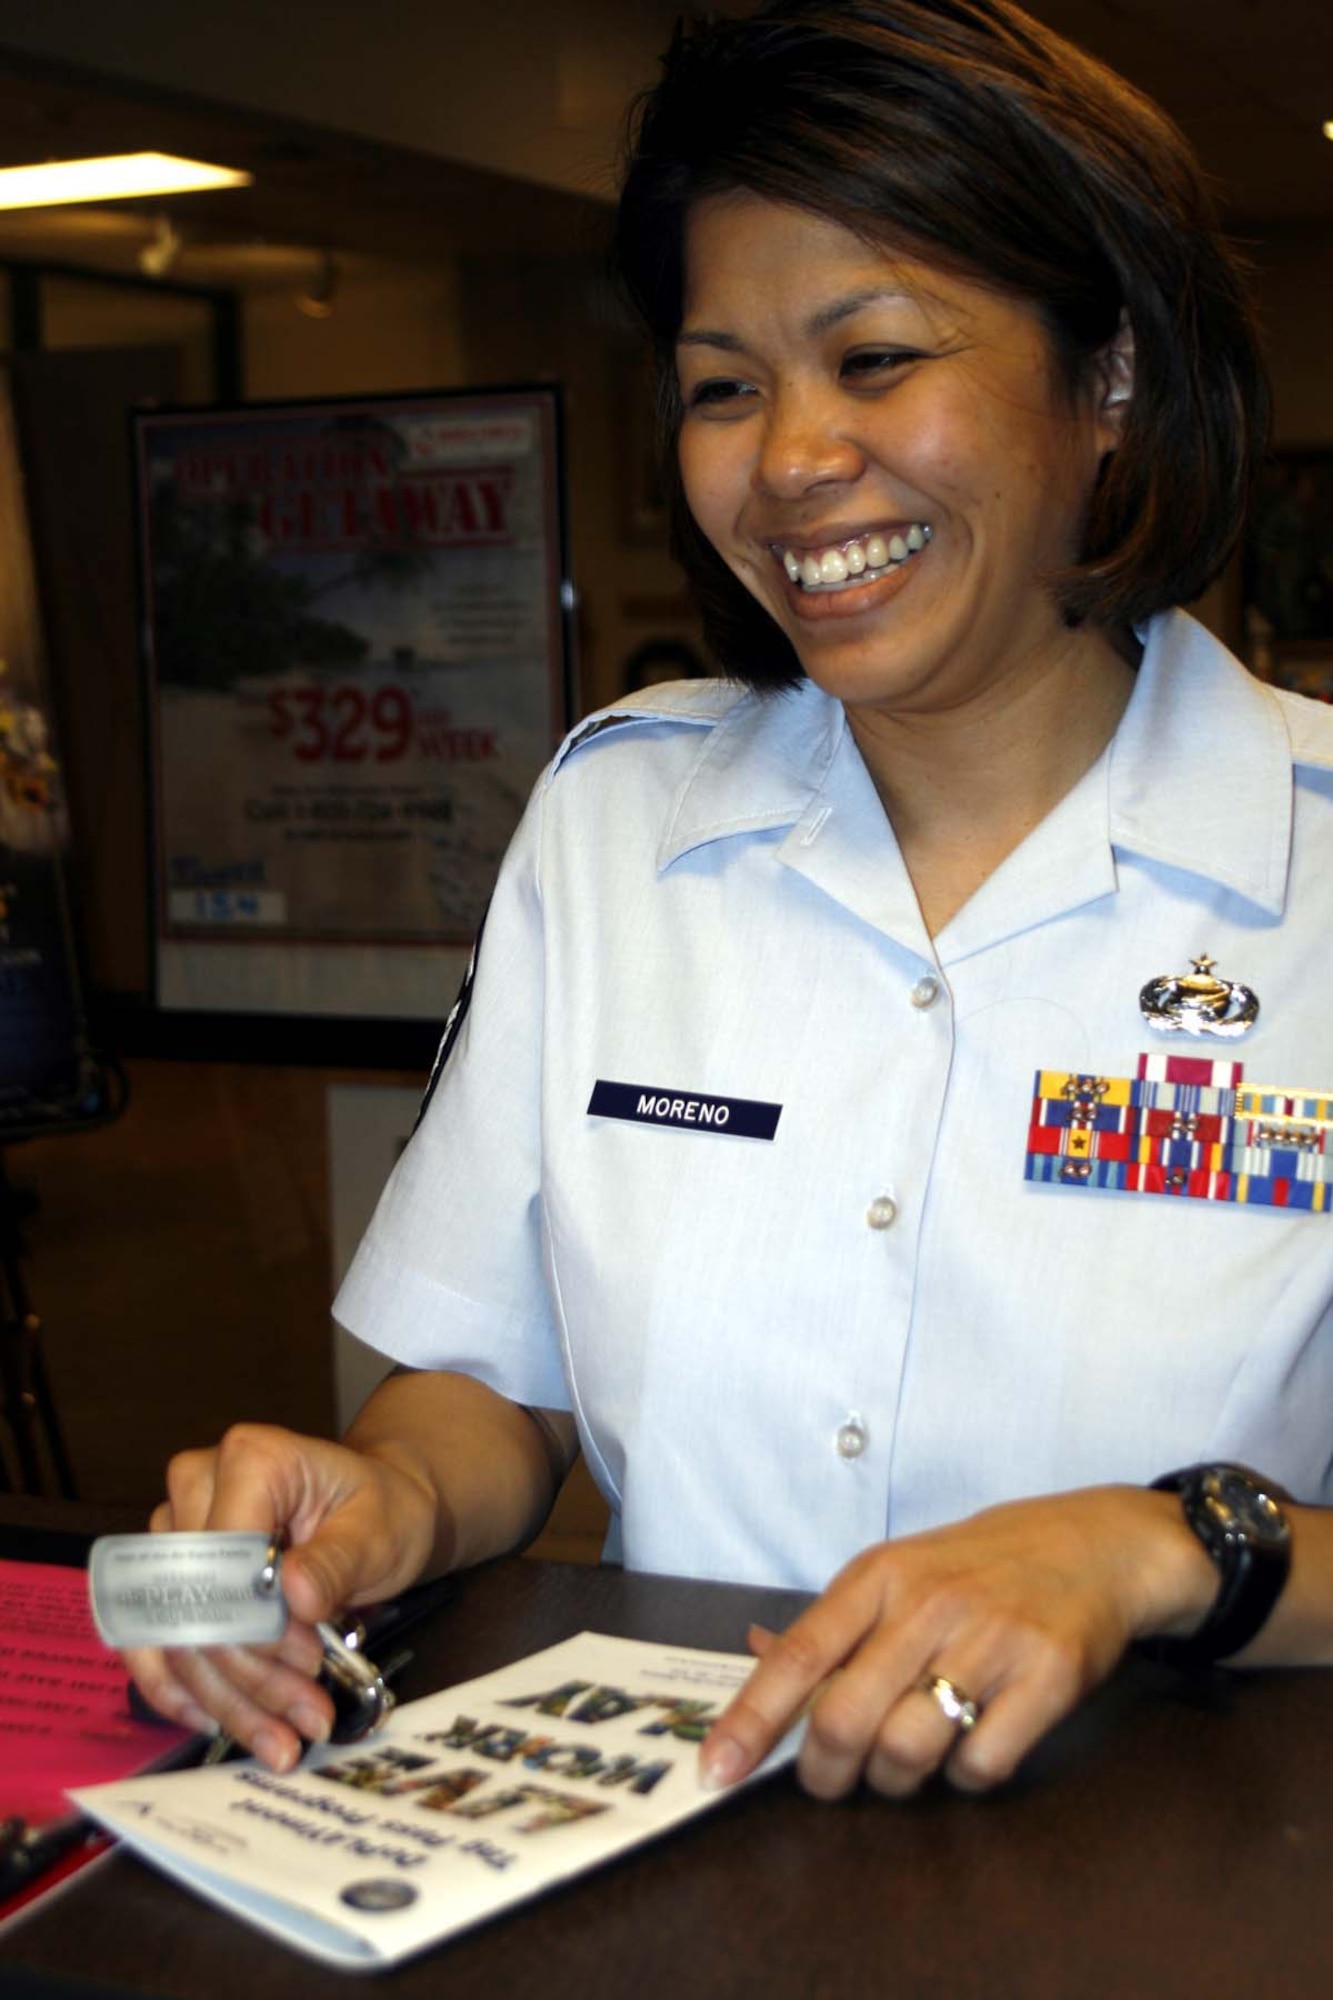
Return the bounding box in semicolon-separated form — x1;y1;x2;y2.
88;1530;286;1648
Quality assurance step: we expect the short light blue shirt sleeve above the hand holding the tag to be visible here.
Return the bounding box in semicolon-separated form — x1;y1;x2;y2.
334;784;568;1410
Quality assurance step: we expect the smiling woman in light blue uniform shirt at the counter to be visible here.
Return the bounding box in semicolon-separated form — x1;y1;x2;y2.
122;0;1333;1798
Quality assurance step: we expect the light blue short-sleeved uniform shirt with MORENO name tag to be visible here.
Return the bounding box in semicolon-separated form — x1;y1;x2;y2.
334;612;1333;1588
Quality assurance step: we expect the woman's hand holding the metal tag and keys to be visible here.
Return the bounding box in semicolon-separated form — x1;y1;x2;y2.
126;1424;436;1770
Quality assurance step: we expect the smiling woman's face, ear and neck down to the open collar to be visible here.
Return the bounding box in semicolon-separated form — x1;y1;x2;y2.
675;192;1137;932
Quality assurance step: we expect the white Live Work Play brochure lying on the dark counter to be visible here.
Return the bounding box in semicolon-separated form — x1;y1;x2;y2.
70;1632;801;1970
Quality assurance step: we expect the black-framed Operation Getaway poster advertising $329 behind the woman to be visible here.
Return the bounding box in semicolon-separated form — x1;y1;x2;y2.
134;388;570;1066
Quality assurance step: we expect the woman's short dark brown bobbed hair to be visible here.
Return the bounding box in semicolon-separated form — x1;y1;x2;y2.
612;0;1269;686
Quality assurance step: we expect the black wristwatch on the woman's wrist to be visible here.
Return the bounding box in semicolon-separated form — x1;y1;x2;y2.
1147;1464;1291;1666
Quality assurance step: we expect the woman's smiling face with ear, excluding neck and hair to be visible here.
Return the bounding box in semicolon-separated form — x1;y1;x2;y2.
677;194;1119;714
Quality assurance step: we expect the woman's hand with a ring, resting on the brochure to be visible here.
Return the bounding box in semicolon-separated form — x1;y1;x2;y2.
701;1486;1217;1798
